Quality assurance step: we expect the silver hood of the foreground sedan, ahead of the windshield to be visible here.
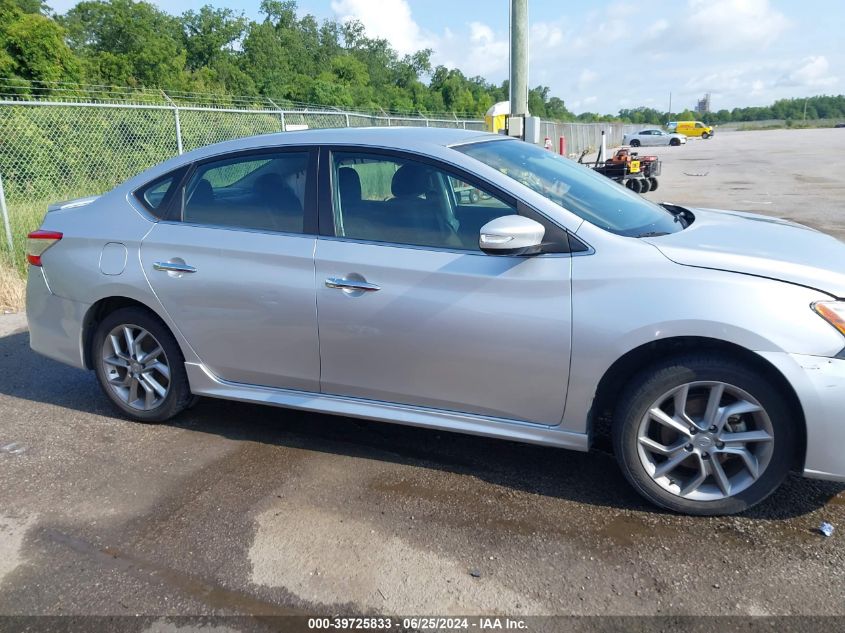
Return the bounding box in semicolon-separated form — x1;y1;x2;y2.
643;209;845;298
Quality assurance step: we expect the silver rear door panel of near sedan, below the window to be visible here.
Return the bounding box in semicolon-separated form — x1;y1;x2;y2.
141;222;320;391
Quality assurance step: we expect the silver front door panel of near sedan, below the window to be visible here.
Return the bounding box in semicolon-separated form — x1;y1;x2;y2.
316;239;572;425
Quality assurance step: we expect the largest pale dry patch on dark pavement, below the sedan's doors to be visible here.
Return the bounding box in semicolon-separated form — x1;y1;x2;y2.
250;503;545;615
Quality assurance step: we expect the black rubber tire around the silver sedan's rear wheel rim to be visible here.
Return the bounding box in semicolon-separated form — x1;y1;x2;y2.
90;307;196;422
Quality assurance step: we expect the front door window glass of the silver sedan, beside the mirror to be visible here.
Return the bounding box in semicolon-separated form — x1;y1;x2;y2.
332;152;517;251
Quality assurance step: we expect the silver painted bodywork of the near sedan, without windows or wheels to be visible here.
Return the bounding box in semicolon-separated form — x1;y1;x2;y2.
27;129;845;480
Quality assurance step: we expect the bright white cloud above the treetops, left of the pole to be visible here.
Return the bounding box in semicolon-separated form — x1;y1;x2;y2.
331;0;435;55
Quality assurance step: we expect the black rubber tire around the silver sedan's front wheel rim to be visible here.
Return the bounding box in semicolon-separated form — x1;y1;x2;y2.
613;354;797;515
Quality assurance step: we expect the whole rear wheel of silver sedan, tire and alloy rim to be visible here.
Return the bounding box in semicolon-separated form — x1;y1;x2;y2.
91;307;193;422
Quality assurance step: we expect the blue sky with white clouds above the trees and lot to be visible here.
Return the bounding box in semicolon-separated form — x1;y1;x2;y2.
48;0;845;113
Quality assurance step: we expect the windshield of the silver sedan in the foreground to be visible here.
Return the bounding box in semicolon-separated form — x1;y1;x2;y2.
454;140;684;237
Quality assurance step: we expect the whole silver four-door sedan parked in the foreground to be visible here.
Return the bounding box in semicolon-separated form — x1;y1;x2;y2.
27;128;845;514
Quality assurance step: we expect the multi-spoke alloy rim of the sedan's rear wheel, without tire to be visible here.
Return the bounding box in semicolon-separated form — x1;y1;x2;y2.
101;324;170;411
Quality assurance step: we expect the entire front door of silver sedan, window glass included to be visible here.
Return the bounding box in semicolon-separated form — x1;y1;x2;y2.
316;150;571;425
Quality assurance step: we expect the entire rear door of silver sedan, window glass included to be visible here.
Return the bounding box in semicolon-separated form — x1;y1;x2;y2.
141;148;320;391
